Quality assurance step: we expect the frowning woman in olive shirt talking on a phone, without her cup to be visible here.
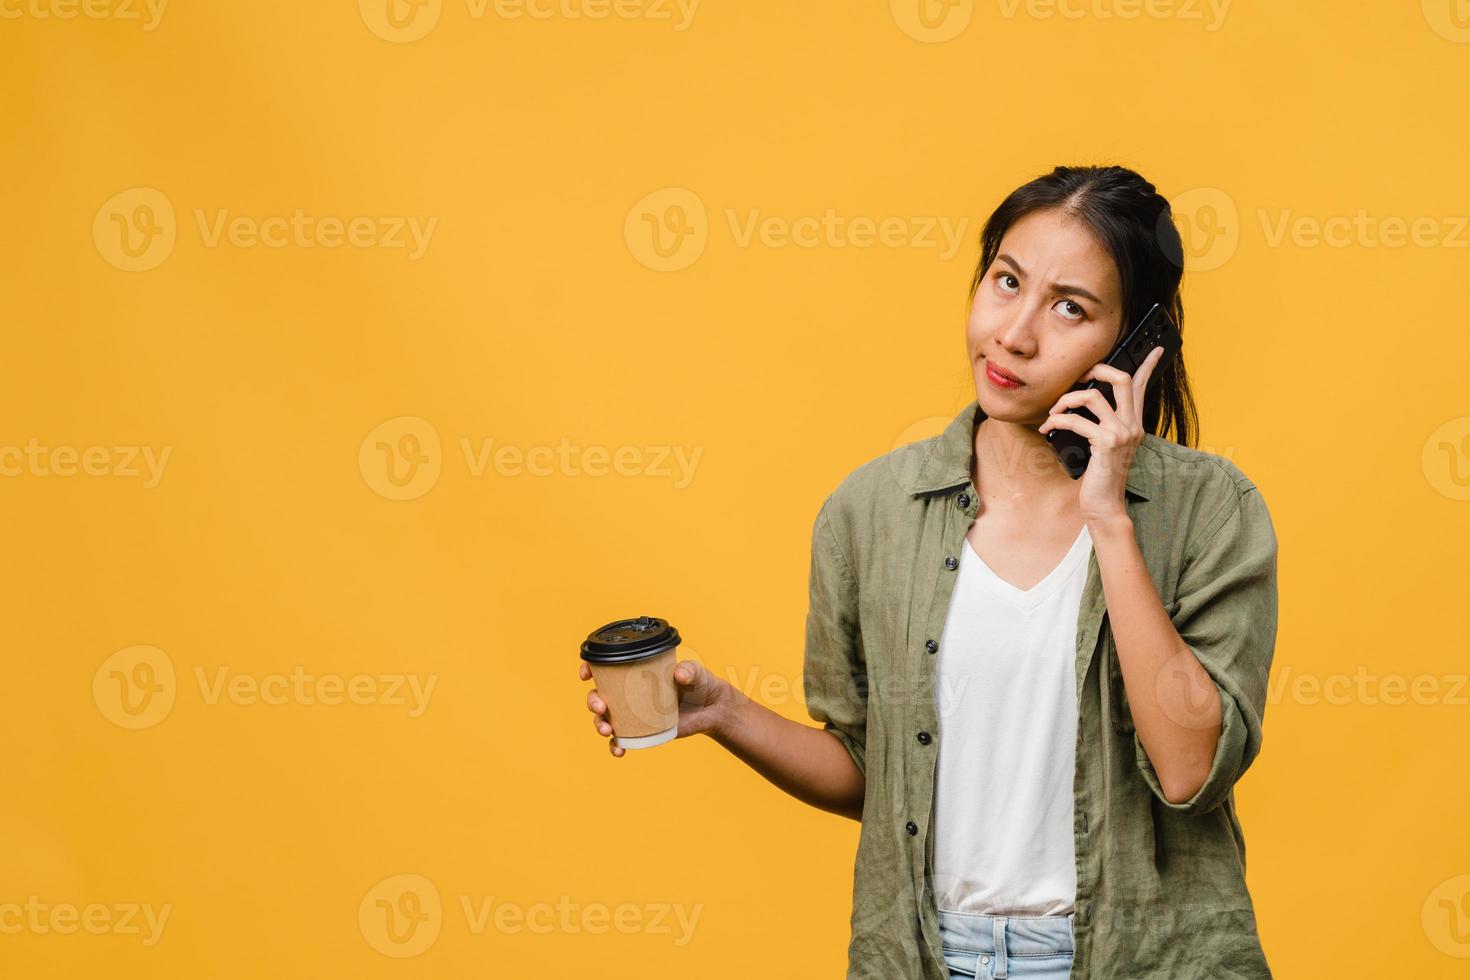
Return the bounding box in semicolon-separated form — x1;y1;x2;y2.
581;167;1276;980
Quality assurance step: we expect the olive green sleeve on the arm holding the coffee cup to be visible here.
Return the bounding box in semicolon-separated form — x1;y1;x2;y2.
803;497;867;777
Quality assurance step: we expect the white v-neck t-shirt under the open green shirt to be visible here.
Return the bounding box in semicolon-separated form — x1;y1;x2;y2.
935;525;1092;915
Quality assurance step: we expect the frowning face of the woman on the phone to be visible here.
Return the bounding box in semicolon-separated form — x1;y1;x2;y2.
964;209;1123;425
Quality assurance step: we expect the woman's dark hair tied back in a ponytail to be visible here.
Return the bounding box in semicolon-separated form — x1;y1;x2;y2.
970;166;1200;445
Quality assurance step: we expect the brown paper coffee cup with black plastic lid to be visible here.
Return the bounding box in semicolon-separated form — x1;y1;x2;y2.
582;616;682;749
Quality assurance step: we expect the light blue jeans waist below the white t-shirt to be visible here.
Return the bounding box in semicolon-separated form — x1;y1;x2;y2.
939;908;1076;980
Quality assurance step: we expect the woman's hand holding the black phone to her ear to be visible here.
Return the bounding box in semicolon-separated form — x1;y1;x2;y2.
1036;347;1164;522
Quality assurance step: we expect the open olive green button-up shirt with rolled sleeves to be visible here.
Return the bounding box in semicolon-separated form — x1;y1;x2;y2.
804;401;1276;980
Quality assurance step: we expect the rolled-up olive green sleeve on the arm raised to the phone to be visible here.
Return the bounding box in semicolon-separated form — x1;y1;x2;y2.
1133;486;1276;814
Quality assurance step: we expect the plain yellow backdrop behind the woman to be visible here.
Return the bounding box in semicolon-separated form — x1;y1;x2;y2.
0;0;1470;980
